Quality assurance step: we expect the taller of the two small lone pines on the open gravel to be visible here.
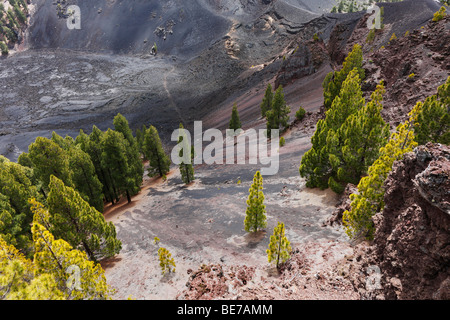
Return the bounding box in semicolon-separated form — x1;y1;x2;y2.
244;171;267;232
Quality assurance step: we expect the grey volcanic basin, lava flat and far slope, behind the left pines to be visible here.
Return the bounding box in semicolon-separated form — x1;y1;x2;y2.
0;0;340;159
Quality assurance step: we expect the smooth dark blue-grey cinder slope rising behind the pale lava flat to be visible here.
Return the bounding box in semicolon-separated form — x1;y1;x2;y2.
30;0;332;57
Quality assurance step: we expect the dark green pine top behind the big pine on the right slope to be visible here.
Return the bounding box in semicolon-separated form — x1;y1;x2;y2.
322;44;365;109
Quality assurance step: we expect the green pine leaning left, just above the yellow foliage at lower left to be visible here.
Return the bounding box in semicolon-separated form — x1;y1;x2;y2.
47;176;121;261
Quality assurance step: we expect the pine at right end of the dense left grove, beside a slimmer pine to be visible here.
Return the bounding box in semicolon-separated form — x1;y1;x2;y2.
142;126;171;177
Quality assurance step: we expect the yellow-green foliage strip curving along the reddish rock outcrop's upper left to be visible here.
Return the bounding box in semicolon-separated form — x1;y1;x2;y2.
343;77;450;239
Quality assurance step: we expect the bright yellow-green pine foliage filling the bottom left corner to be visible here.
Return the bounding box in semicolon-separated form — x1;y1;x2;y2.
0;222;112;300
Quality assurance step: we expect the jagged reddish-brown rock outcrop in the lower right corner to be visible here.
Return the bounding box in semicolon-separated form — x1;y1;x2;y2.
370;143;450;300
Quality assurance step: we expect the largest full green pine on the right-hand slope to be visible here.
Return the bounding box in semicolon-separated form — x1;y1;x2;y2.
299;68;389;192
